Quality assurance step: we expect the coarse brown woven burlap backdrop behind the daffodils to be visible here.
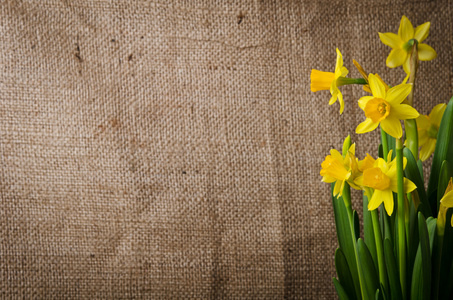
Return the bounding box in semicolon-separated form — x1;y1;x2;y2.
0;0;453;299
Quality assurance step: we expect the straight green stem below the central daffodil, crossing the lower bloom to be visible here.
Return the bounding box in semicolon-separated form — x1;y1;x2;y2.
396;139;407;299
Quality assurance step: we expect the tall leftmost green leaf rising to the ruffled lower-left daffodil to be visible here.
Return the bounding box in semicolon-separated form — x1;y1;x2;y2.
332;184;361;299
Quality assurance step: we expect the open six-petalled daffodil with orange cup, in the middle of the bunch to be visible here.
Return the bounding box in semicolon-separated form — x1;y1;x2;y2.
356;74;419;138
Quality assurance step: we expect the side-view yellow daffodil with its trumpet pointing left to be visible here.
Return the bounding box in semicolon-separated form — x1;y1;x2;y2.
310;48;349;114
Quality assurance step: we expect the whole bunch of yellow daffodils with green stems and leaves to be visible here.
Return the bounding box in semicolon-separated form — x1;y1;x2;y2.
311;16;453;300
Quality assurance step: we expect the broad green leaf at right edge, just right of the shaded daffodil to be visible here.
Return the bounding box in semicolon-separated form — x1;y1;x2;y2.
427;97;453;211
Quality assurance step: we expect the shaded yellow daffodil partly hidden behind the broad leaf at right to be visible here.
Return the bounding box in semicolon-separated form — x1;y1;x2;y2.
417;104;447;161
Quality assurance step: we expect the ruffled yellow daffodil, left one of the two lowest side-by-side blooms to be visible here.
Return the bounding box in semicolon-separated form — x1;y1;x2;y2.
320;144;360;196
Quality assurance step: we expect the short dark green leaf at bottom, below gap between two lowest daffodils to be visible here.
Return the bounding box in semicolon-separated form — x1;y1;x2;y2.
357;238;379;299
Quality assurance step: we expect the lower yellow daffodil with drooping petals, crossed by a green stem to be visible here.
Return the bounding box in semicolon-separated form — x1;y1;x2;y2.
355;153;417;216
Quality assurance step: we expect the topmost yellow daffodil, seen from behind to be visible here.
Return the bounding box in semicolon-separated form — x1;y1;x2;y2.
379;16;437;74
